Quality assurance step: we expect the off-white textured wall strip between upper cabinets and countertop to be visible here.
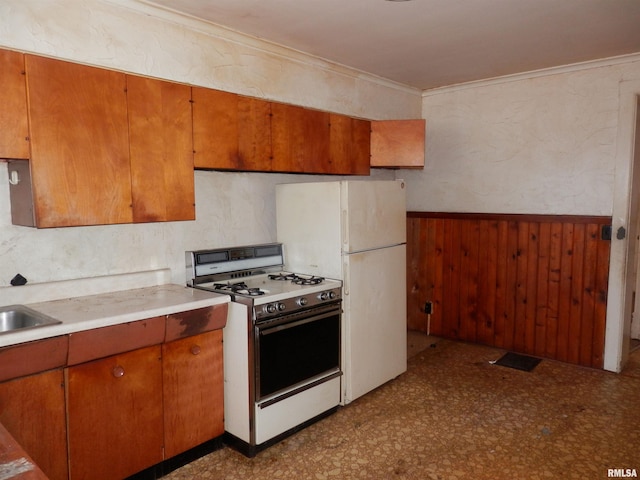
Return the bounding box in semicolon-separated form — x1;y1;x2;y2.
0;167;394;290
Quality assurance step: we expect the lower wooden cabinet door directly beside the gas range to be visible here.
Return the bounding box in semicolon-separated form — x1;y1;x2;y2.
162;330;224;458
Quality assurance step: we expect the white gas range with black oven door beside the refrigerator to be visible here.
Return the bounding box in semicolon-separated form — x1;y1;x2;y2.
186;243;342;456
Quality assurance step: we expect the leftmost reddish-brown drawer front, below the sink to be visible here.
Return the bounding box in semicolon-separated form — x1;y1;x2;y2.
0;336;69;382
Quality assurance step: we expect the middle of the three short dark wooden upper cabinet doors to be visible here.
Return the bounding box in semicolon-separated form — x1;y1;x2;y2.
271;103;331;173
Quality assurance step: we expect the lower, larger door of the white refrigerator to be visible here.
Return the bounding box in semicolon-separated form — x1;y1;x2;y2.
342;245;407;404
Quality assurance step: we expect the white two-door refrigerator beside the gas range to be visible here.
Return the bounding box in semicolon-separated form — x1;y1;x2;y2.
276;180;407;404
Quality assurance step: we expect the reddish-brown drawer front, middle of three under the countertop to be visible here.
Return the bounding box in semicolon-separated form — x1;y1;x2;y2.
67;317;165;365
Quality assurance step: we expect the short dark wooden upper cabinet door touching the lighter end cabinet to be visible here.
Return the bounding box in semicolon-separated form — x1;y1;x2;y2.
327;113;371;175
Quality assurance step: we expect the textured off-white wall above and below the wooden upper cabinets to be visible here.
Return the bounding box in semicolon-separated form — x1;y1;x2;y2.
0;0;421;287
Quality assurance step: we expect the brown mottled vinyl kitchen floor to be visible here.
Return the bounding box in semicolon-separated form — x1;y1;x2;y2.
163;332;640;480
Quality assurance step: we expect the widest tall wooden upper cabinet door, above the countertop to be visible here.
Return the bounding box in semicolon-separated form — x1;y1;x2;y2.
25;55;132;227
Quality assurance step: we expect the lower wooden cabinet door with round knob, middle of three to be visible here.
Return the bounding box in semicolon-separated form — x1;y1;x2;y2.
66;345;163;480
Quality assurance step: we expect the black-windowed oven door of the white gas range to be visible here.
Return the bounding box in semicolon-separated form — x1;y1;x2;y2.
255;302;342;407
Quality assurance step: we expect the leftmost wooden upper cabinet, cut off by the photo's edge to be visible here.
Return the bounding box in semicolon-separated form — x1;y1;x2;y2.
0;49;29;158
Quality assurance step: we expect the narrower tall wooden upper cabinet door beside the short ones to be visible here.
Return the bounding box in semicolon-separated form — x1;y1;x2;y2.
127;75;195;222
